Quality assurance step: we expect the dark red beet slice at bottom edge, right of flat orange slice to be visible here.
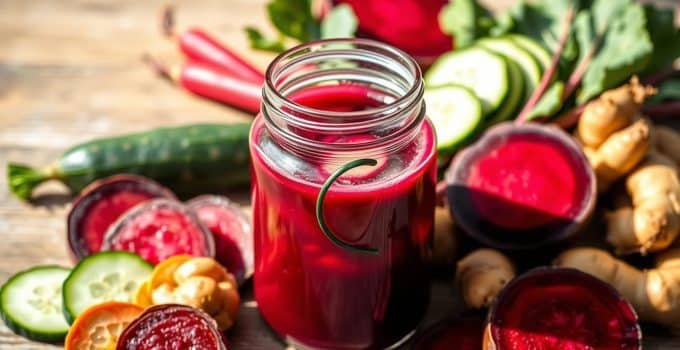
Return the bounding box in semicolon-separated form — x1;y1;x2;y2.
116;304;227;350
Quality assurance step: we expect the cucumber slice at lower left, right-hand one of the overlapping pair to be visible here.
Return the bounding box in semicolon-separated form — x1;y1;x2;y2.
63;251;153;323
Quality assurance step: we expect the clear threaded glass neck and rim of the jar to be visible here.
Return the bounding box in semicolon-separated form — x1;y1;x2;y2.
261;38;425;157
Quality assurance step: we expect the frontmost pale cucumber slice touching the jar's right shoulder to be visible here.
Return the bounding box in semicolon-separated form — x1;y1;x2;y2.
425;84;482;157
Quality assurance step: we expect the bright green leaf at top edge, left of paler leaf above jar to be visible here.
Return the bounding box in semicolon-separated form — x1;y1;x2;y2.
267;0;321;42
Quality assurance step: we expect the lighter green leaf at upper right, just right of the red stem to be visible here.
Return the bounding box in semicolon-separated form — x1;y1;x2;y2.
576;0;654;104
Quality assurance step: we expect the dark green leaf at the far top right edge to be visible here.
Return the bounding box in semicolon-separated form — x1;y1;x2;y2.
643;5;680;75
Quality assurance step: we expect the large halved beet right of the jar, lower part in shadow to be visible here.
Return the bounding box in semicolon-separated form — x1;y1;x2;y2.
445;123;597;249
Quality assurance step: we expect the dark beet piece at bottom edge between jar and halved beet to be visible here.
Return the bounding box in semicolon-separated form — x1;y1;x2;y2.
413;317;484;350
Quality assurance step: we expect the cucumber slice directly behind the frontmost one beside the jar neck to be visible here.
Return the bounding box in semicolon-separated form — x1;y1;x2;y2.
425;47;508;115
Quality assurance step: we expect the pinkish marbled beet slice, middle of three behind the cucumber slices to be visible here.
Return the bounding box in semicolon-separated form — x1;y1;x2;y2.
104;199;215;264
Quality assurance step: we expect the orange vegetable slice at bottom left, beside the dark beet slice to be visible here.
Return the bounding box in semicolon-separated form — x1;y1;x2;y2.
64;301;144;350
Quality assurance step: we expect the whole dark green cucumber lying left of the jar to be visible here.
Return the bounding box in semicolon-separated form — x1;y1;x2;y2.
7;123;250;199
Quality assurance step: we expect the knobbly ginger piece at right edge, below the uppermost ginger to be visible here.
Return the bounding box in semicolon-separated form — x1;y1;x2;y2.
605;155;680;253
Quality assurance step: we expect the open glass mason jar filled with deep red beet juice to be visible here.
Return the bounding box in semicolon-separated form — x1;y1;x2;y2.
250;39;436;349
